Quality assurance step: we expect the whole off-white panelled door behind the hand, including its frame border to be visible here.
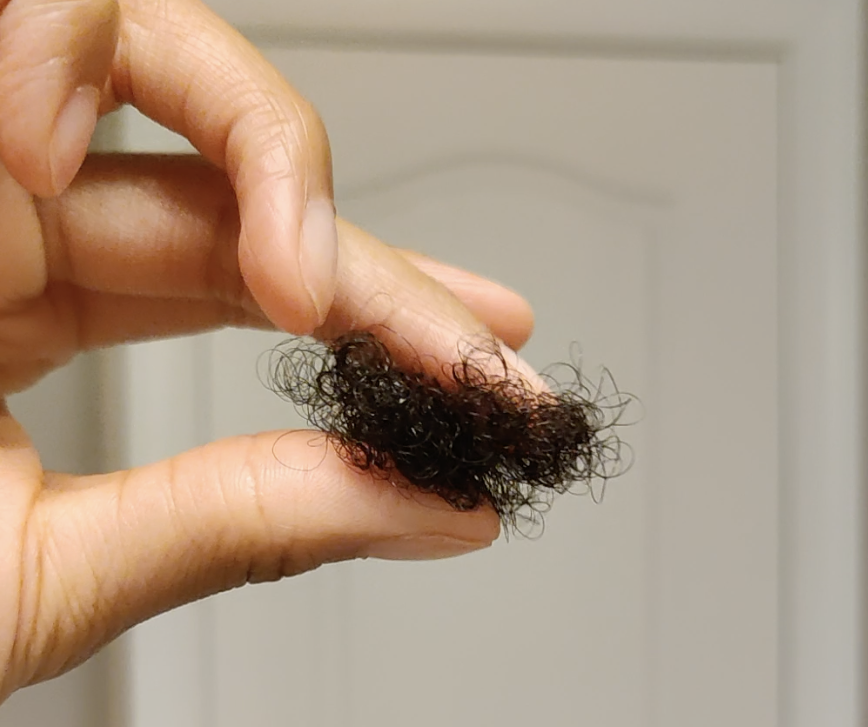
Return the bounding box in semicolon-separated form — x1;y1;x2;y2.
110;1;859;727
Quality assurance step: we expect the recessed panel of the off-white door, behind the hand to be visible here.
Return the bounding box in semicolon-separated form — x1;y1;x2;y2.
200;48;778;727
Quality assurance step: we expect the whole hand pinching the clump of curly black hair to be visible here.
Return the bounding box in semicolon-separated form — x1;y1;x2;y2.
0;0;544;700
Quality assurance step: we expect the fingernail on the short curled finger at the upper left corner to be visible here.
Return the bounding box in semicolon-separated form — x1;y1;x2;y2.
48;86;100;194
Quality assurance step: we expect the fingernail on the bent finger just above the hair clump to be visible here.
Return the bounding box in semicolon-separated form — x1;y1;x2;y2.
298;199;338;326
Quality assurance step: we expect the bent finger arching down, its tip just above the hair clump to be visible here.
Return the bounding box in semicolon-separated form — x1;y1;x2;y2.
111;0;338;334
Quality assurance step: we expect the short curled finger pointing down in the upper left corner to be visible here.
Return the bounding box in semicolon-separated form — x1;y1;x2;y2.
0;0;119;197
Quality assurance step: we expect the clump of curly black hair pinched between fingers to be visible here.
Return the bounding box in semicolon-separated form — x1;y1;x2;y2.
268;333;631;530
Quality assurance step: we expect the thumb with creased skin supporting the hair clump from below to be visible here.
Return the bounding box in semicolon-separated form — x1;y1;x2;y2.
13;431;499;685
